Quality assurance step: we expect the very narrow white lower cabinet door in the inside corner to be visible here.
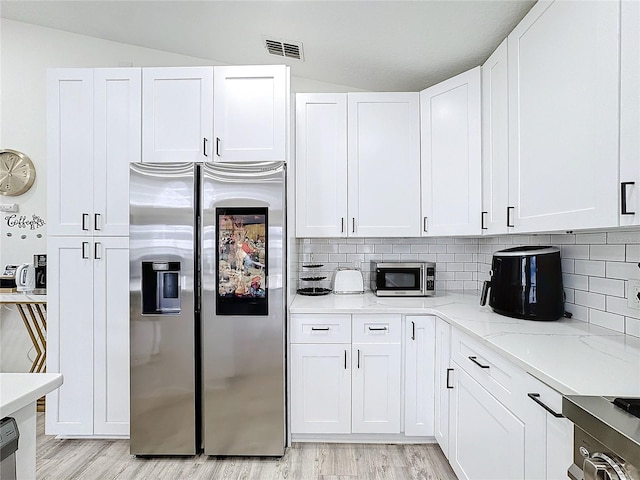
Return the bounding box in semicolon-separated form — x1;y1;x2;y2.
435;318;452;458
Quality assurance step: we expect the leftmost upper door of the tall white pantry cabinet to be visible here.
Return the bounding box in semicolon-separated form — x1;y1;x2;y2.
47;68;93;236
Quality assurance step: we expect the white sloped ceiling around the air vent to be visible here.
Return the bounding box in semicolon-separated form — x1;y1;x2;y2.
0;0;535;91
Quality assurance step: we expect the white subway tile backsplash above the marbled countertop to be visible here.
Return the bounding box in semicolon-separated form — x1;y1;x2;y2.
297;229;640;337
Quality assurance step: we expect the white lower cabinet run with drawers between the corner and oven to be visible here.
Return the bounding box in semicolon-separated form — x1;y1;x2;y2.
436;328;573;480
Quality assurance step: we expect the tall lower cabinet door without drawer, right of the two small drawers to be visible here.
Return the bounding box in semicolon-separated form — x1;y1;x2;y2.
404;316;435;437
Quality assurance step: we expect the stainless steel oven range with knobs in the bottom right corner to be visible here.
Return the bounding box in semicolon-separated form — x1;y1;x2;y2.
562;395;640;480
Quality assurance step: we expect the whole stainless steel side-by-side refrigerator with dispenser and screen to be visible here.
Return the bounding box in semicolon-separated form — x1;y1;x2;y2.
129;162;286;456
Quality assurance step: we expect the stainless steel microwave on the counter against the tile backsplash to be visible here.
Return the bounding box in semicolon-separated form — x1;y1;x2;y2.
371;262;436;297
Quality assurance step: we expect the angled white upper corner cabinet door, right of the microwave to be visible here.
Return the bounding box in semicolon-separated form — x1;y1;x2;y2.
420;67;482;235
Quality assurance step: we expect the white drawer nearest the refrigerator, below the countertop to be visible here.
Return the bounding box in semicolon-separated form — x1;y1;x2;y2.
291;313;351;343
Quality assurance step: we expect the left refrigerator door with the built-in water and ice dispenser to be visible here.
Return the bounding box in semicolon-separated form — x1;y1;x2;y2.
129;164;197;455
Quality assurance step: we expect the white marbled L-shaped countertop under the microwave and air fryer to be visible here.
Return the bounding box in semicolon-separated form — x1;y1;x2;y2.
289;292;640;397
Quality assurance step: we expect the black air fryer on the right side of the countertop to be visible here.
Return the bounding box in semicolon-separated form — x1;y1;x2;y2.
480;246;564;320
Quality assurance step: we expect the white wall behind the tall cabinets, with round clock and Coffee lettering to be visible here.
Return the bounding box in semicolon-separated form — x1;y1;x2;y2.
0;19;359;372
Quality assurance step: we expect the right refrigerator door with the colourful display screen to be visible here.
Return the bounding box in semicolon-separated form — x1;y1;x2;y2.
201;162;285;456
